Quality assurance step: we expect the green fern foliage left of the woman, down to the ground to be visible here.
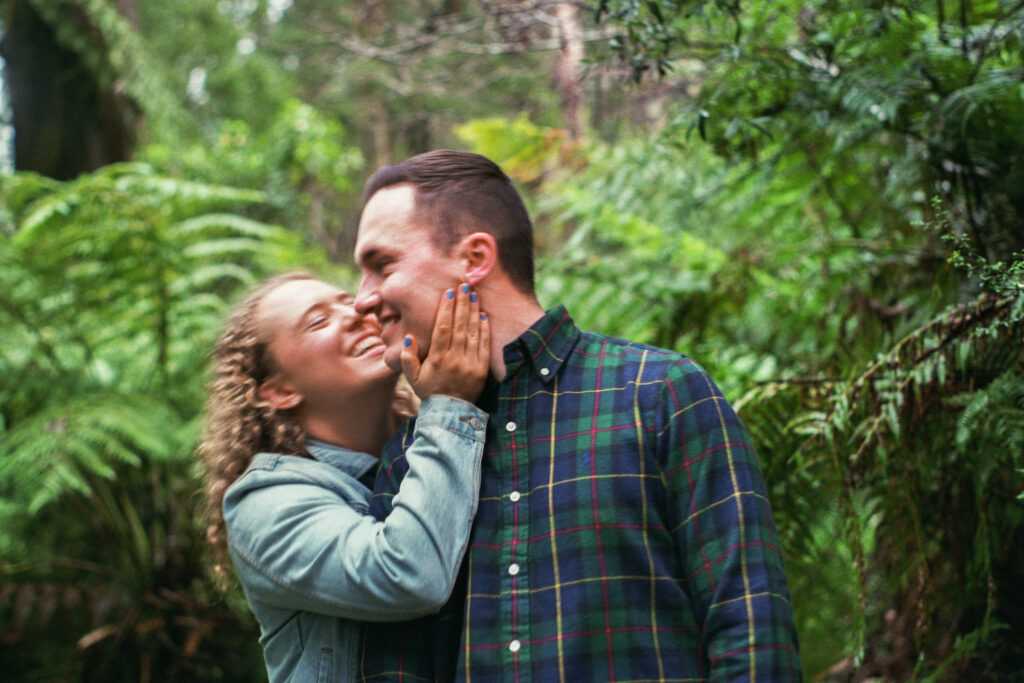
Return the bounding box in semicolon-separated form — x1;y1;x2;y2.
0;164;319;680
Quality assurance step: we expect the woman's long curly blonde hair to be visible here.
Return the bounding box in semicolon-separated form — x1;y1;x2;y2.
196;271;418;578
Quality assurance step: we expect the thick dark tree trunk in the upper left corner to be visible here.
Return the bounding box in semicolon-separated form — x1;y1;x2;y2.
0;0;139;180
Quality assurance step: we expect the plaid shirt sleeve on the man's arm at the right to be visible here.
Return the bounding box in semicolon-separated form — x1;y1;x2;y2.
657;359;802;681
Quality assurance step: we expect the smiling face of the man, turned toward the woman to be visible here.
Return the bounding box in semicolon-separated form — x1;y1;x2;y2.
355;184;461;370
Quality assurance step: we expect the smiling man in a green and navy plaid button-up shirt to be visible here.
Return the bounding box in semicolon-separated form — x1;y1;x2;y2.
355;151;801;683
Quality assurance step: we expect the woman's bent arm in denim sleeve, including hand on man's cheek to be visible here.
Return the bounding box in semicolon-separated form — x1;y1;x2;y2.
224;292;489;621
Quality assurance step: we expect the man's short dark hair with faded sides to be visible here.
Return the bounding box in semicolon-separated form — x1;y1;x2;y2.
362;150;534;294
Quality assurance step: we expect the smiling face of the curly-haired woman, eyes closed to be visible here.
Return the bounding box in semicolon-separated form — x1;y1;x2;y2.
256;280;398;412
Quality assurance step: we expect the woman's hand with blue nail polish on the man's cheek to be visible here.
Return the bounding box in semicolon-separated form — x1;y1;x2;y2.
401;285;490;402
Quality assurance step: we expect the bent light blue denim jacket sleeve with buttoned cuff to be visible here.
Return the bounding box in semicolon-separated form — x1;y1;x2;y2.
225;396;487;621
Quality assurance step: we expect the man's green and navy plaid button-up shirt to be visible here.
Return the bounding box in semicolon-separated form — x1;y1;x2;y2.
362;306;801;683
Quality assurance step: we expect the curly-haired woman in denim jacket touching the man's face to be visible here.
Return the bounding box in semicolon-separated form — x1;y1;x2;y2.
199;273;489;682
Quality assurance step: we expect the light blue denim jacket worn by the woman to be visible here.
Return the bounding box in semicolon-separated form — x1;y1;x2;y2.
224;396;487;683
